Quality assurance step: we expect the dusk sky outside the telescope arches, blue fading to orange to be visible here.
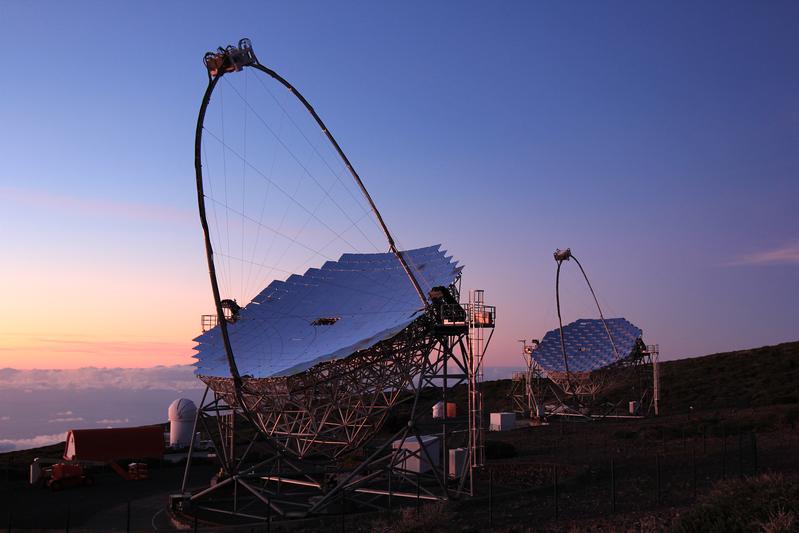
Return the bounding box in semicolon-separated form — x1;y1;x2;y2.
0;0;799;369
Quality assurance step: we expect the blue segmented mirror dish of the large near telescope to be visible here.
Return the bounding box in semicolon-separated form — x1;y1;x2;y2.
194;245;463;378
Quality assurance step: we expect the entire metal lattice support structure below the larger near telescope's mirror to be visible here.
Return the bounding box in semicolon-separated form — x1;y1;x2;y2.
177;312;493;521
